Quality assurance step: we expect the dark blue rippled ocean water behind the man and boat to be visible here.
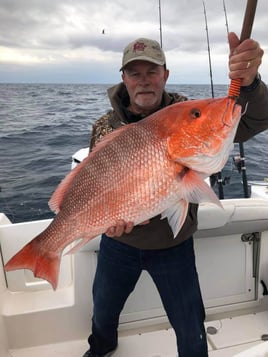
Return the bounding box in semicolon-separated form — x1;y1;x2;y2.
0;84;268;223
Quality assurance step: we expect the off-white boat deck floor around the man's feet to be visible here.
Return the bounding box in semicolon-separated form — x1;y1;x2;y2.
7;312;268;357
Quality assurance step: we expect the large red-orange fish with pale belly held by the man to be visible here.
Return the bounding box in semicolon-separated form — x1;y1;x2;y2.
5;96;241;290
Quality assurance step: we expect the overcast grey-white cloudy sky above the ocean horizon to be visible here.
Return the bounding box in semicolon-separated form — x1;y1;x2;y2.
0;0;268;84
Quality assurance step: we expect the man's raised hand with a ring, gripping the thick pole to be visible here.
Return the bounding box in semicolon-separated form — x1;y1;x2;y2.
228;32;264;86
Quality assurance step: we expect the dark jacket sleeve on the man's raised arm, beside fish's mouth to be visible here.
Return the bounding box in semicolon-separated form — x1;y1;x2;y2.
234;81;268;142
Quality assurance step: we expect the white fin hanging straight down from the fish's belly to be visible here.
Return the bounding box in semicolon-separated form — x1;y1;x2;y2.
161;200;189;238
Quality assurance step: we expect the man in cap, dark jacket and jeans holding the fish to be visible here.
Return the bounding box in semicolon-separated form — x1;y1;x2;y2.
84;33;268;357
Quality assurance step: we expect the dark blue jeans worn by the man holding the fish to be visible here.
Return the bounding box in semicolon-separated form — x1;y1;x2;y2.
88;235;208;357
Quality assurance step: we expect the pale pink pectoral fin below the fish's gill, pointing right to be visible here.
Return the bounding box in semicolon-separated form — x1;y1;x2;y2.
181;170;223;208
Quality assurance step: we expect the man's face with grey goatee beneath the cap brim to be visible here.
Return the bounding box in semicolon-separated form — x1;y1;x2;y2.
122;60;169;115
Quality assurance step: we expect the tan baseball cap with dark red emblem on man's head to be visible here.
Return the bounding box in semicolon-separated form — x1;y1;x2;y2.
120;38;166;71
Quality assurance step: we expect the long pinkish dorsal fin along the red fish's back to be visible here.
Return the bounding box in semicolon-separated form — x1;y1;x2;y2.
48;123;135;213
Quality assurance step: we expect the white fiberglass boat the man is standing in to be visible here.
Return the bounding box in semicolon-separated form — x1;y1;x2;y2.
0;149;268;357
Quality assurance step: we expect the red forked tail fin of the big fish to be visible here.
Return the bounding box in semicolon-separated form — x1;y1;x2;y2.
5;239;60;290
